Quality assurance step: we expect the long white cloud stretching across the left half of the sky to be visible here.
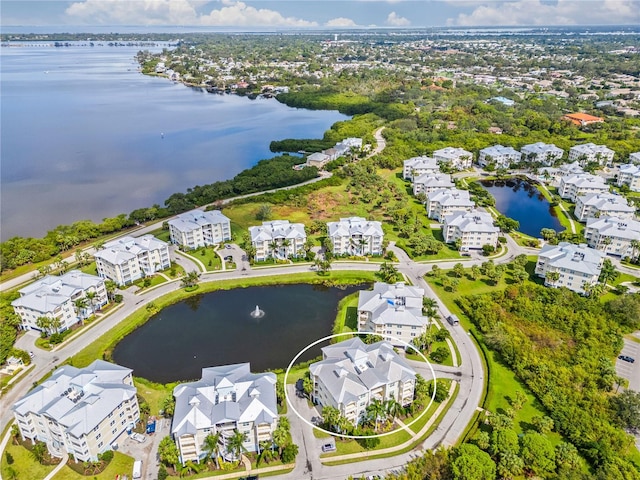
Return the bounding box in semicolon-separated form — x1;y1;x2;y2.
66;0;318;27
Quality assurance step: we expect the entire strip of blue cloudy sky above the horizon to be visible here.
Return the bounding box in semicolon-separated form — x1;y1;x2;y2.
0;0;640;32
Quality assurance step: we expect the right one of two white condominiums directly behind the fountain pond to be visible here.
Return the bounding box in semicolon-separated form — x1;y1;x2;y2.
327;217;384;256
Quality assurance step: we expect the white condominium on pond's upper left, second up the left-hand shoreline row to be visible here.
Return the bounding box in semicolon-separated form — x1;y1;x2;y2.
93;234;171;285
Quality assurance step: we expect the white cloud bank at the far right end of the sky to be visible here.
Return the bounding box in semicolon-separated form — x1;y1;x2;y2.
447;0;640;26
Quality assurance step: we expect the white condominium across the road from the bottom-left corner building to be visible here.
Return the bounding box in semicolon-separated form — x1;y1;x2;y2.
11;270;108;333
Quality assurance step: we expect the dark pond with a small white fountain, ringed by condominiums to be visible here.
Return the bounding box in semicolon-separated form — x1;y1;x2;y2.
113;284;362;383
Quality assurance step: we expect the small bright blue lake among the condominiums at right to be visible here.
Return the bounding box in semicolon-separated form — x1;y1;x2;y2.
480;178;563;238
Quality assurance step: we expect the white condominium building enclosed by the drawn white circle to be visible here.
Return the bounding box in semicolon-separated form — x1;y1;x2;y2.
309;338;416;425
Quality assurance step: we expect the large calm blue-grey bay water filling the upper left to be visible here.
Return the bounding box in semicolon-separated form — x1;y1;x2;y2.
0;46;347;240
